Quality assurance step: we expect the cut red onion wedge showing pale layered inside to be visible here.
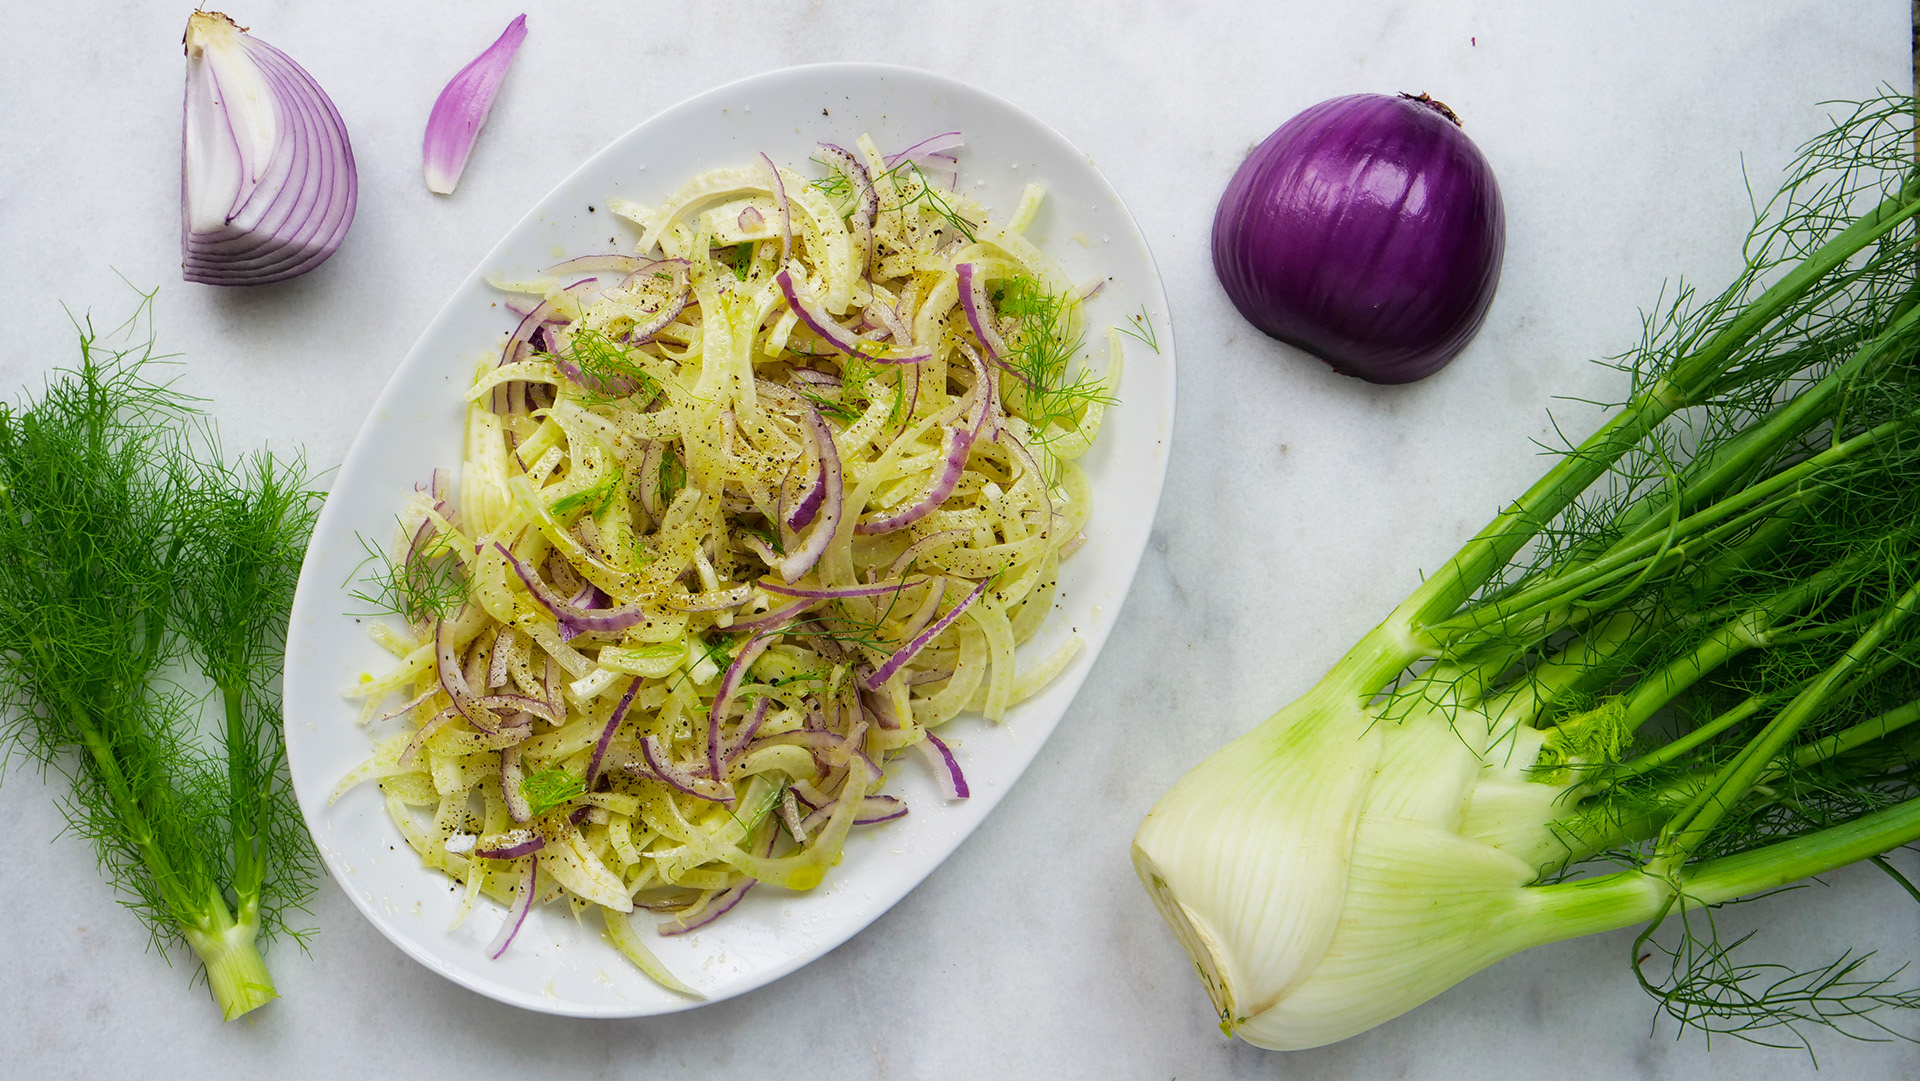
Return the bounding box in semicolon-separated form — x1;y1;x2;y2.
180;12;359;286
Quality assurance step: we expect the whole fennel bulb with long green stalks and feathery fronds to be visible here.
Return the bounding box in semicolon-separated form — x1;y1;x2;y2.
1135;98;1920;1050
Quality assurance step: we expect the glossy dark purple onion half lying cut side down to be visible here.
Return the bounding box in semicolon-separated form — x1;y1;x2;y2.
1213;94;1507;384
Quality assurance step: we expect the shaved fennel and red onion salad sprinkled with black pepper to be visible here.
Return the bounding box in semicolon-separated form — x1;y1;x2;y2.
334;132;1128;993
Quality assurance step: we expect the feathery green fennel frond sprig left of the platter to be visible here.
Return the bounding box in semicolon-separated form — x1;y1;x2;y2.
0;305;317;1020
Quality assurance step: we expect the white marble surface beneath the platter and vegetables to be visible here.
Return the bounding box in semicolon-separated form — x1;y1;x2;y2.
0;0;1920;1081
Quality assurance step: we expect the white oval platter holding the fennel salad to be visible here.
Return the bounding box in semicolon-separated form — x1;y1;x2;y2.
286;63;1173;1018
